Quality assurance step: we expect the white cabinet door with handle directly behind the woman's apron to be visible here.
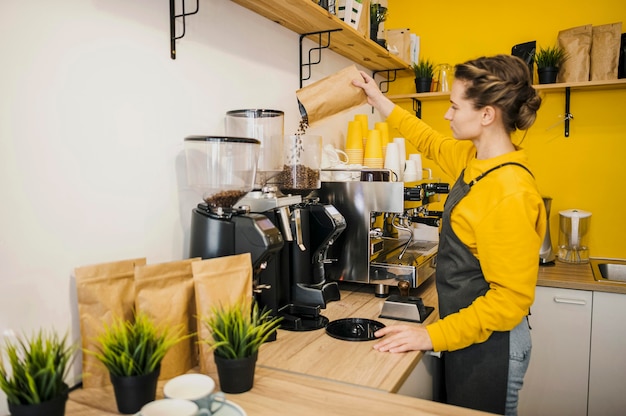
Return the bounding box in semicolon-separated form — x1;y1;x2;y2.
519;286;588;416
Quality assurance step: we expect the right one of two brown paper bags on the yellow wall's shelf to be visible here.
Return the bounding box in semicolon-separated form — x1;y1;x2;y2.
589;22;622;81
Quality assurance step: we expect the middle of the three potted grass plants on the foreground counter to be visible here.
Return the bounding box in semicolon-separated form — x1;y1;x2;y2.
85;313;188;414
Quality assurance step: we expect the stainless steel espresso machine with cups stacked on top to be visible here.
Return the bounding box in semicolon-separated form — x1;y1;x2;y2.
316;174;449;297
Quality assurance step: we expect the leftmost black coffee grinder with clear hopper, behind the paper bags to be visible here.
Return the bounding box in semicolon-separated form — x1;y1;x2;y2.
185;136;283;292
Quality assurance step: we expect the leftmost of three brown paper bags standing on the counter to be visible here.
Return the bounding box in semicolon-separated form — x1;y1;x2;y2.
74;258;146;388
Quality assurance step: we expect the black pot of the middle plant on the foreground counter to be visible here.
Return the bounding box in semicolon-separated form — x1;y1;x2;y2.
109;366;161;414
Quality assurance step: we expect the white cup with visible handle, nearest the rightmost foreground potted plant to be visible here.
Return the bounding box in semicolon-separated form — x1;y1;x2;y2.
163;374;226;415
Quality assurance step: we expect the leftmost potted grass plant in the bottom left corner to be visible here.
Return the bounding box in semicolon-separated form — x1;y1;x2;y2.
0;329;77;416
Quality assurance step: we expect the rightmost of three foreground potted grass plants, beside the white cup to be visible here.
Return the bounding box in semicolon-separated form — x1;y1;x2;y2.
201;299;282;393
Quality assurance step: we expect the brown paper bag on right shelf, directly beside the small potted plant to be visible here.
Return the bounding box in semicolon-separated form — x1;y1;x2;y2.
557;25;592;82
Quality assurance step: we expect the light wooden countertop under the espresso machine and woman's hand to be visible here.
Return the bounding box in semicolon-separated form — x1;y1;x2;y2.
258;278;439;393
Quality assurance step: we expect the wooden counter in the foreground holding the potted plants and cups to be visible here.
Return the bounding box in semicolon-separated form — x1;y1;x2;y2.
65;367;488;416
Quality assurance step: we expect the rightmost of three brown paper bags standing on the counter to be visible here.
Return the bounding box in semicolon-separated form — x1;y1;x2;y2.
191;253;252;374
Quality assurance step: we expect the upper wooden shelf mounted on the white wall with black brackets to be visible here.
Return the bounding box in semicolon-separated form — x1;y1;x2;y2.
232;0;410;71
